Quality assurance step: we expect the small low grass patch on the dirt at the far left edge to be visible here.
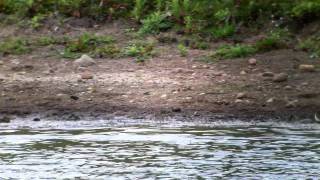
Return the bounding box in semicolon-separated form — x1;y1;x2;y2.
0;38;31;55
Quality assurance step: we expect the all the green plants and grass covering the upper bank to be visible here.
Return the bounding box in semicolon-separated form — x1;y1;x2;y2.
0;0;320;59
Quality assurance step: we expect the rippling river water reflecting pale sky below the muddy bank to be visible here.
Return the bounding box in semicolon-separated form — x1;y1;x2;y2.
0;119;320;180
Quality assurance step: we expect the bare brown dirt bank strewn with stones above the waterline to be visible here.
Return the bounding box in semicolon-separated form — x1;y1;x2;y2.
0;19;320;120
